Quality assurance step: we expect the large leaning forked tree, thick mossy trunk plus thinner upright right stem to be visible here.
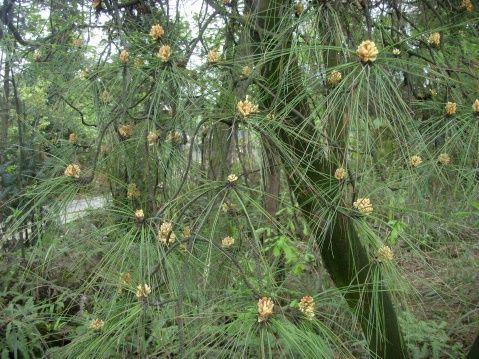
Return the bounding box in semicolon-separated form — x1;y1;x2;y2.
255;0;408;358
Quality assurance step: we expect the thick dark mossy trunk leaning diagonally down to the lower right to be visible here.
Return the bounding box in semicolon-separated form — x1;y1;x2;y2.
255;0;408;358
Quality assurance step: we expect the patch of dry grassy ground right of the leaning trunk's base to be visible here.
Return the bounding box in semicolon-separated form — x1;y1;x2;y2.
397;233;479;353
